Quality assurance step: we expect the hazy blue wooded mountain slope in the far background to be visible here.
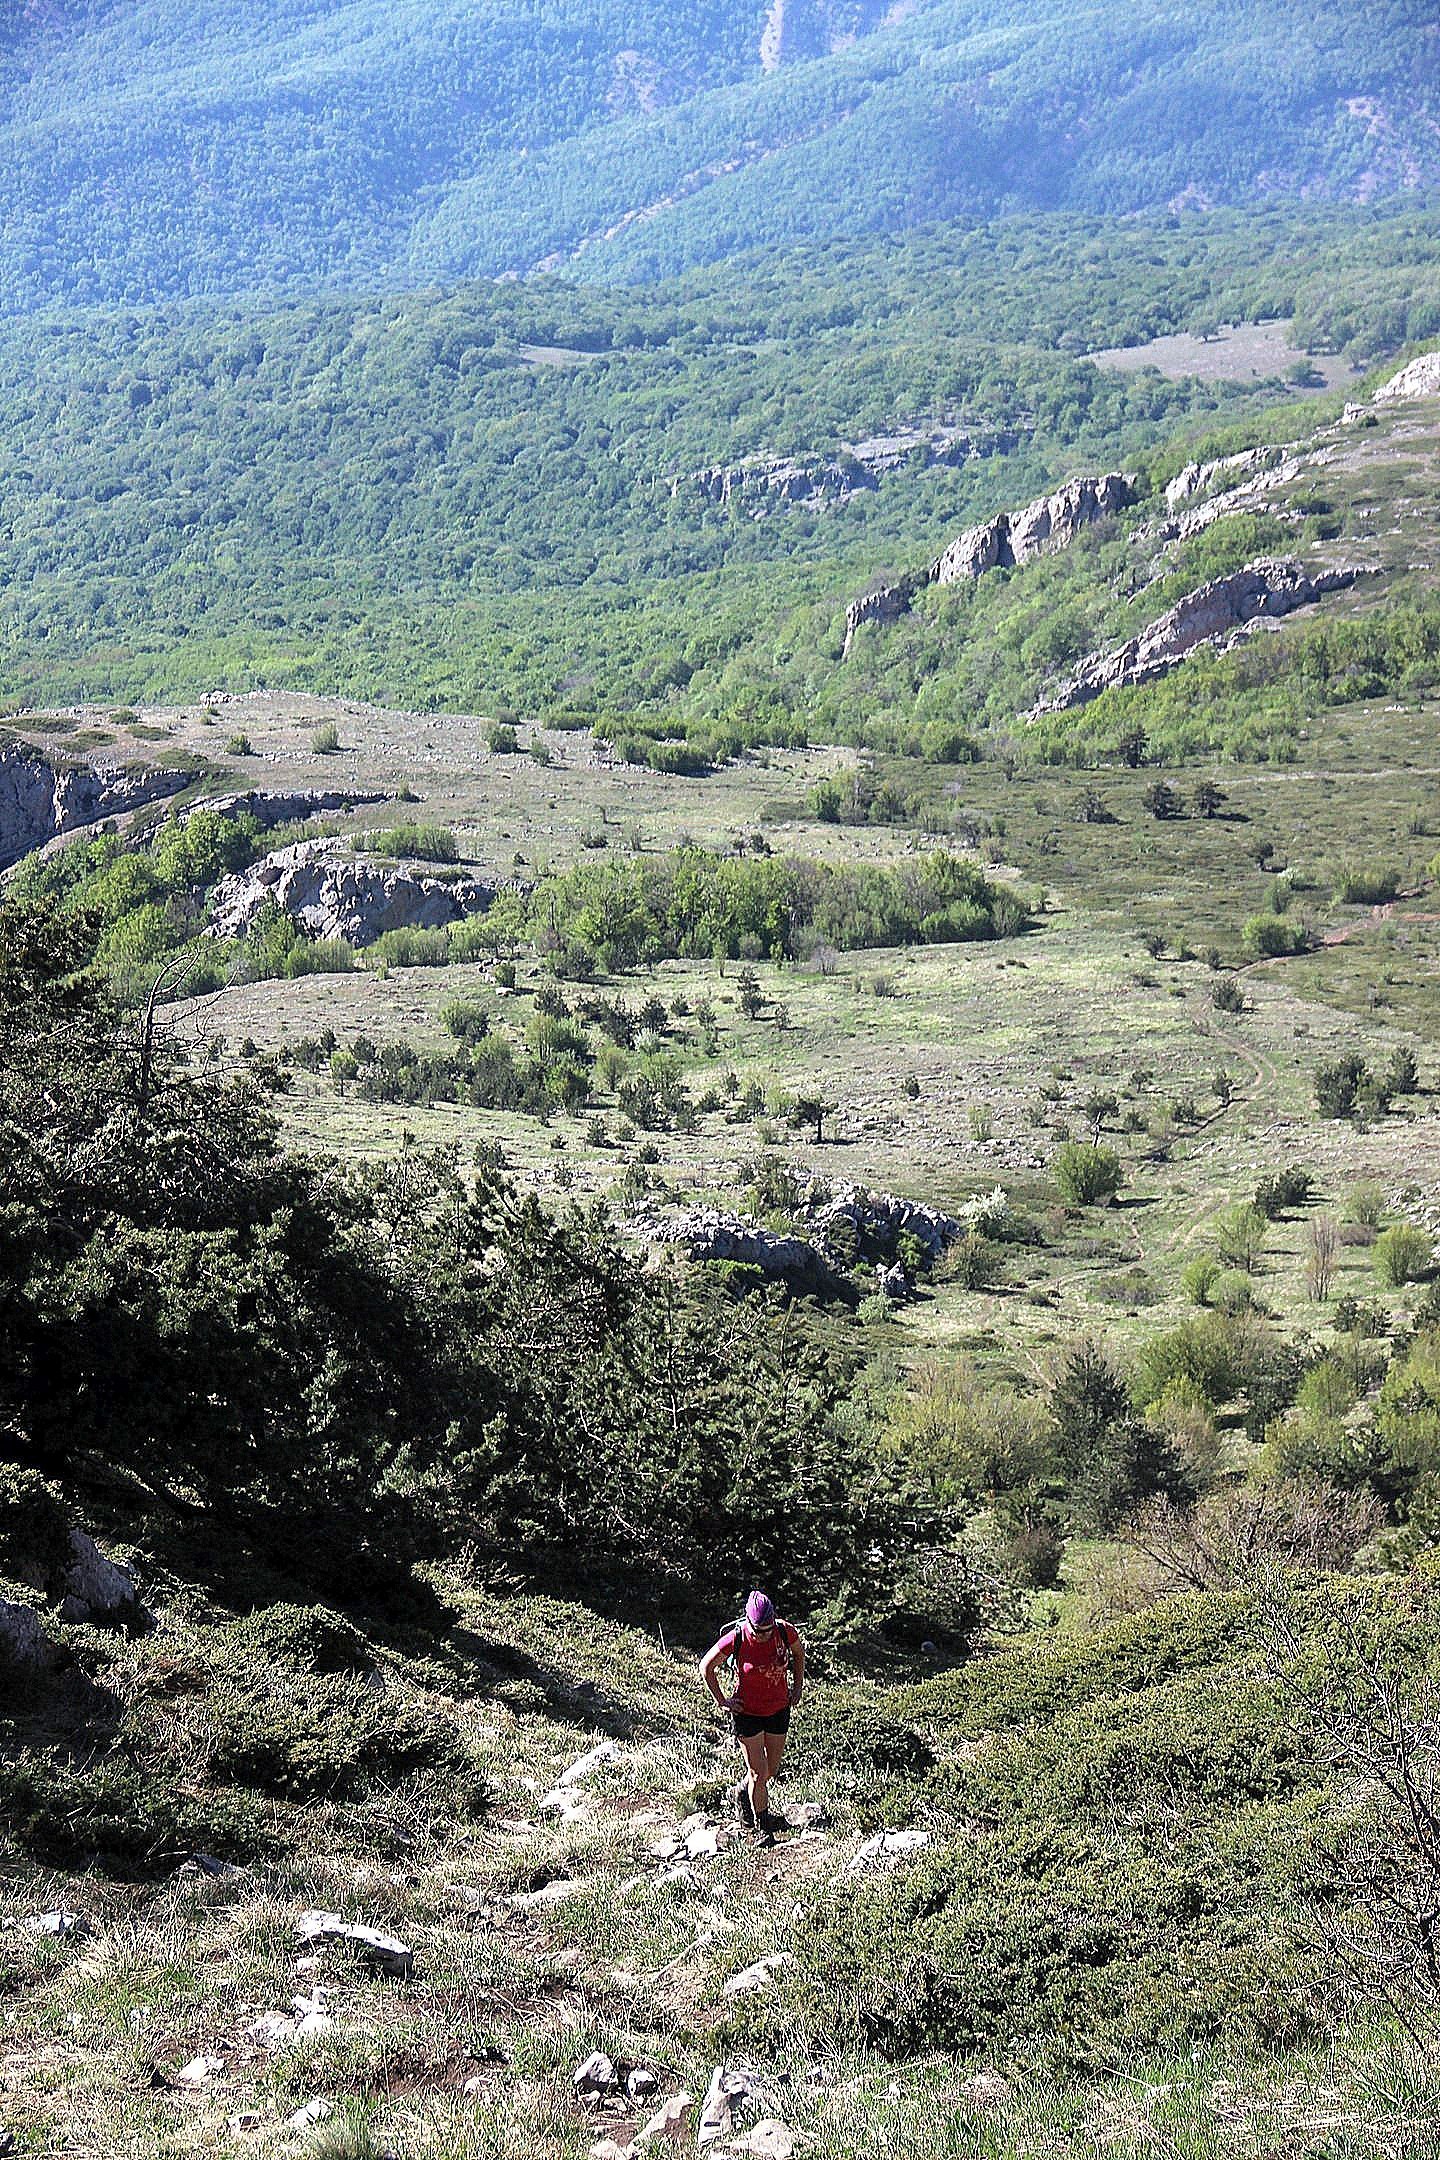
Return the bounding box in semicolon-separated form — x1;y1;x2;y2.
0;0;1440;311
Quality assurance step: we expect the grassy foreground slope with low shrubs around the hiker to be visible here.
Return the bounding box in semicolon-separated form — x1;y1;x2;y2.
0;1555;1434;2160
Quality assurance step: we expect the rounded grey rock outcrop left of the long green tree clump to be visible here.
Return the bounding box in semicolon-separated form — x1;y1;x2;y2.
212;840;494;946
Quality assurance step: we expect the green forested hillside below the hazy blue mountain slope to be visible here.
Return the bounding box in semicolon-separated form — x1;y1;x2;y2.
0;205;1440;713
